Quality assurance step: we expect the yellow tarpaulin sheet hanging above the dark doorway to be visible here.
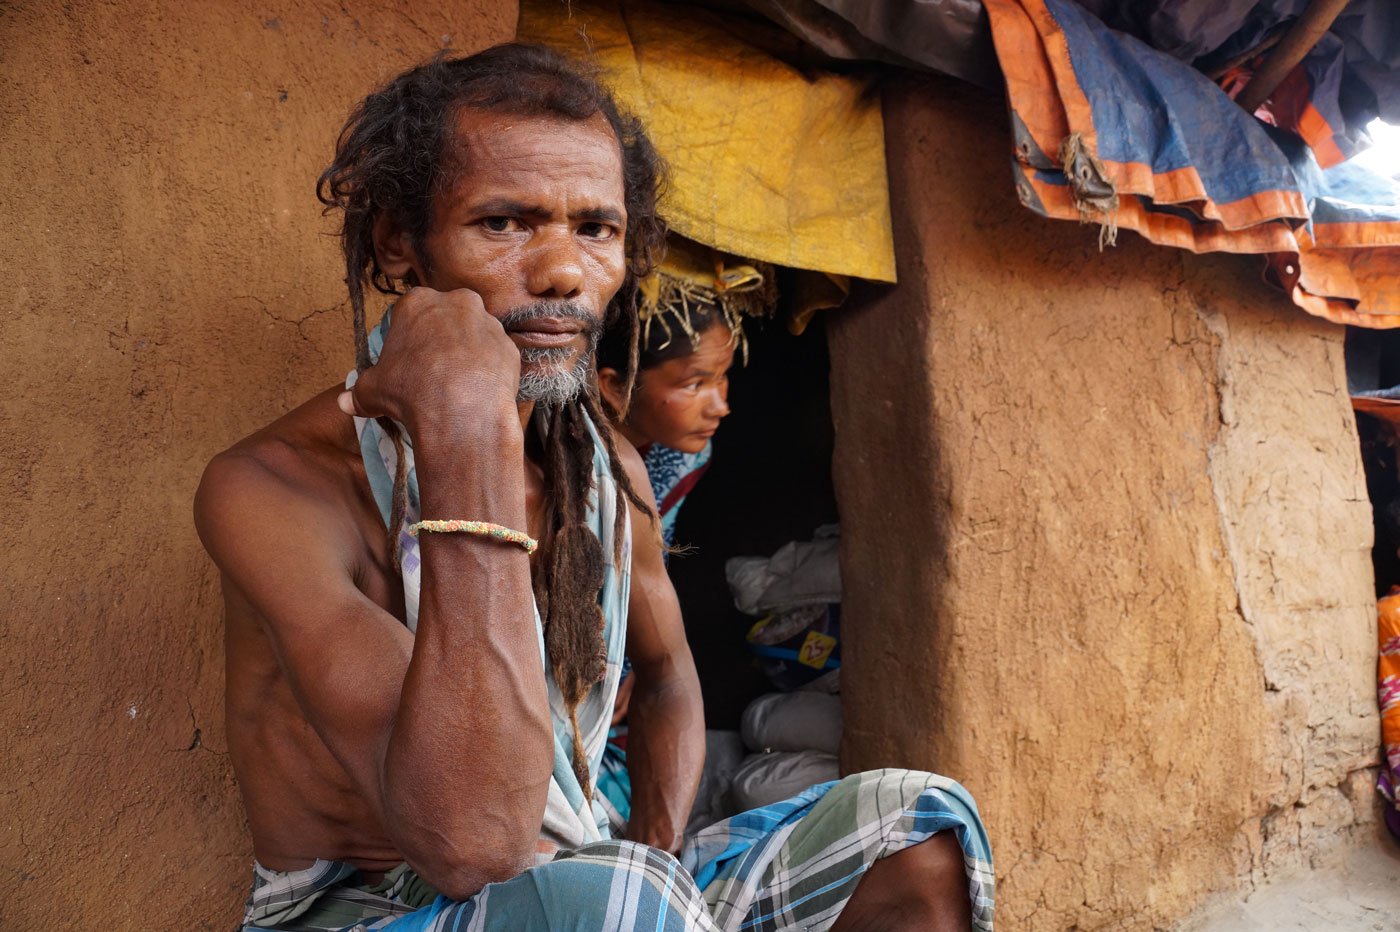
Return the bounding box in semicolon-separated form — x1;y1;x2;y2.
518;0;895;281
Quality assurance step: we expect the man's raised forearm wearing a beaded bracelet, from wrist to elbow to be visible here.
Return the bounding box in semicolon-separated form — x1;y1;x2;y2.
382;411;553;898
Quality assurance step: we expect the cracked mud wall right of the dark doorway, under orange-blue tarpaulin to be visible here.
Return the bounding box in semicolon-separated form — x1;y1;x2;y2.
830;81;1378;929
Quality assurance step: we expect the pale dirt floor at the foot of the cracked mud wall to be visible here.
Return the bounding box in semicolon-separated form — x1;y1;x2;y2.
1176;830;1400;932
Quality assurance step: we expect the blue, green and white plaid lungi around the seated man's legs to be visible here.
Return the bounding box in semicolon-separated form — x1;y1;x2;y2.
244;770;994;932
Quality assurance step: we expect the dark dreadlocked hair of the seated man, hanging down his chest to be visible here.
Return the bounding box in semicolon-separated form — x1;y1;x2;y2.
316;43;665;791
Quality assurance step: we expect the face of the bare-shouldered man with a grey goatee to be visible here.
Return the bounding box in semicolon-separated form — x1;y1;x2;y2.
400;108;627;403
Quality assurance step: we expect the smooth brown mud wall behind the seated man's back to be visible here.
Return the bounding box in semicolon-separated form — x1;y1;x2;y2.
0;0;515;932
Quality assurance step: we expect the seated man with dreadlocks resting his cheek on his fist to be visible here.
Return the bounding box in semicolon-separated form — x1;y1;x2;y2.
195;45;991;932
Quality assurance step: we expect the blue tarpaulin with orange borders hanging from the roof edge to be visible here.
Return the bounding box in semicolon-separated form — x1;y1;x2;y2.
984;0;1400;327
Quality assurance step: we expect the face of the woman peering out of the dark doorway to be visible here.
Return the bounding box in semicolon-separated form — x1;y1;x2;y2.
620;323;734;453
